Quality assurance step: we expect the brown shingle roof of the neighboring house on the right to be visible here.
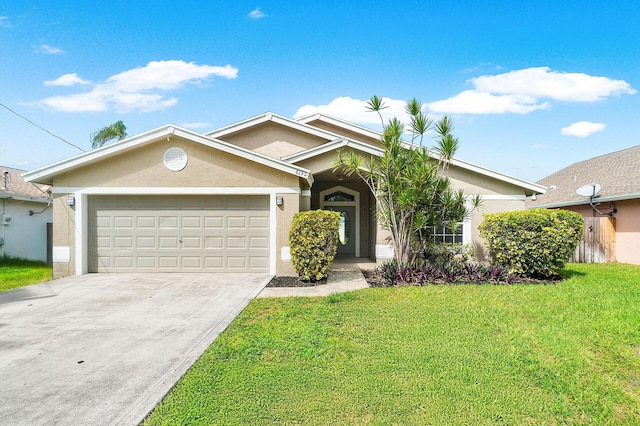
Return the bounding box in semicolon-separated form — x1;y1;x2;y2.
527;145;640;208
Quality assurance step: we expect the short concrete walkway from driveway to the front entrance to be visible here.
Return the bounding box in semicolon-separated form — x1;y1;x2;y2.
258;257;376;297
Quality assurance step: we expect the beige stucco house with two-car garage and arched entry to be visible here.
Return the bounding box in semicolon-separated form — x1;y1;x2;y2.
25;113;544;277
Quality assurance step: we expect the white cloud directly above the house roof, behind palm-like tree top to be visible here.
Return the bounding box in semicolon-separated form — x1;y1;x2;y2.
293;96;408;124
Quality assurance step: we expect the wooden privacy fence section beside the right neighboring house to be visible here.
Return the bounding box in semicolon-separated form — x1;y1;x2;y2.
569;216;616;263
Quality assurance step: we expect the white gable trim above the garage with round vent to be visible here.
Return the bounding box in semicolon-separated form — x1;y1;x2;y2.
24;124;313;184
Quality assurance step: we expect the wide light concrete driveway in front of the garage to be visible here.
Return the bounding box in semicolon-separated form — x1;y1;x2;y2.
0;274;270;425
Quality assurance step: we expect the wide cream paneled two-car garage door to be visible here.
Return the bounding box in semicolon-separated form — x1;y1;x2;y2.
88;196;269;272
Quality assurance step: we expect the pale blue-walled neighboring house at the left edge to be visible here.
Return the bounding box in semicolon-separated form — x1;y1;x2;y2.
0;166;53;262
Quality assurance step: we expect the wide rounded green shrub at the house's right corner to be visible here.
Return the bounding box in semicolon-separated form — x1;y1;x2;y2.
478;209;583;278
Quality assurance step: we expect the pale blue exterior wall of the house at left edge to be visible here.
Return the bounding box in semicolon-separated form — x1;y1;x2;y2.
0;199;53;262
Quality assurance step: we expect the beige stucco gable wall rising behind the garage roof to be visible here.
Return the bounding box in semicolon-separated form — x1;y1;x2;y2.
220;122;327;158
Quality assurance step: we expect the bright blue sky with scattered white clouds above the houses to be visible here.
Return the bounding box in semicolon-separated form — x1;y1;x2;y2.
0;0;640;181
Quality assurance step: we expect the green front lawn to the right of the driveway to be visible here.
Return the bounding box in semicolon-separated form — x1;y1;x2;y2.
145;264;640;425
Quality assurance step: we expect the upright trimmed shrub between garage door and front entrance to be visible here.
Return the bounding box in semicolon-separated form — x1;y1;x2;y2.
289;210;340;281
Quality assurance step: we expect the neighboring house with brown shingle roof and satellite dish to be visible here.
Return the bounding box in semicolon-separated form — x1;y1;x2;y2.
527;145;640;264
